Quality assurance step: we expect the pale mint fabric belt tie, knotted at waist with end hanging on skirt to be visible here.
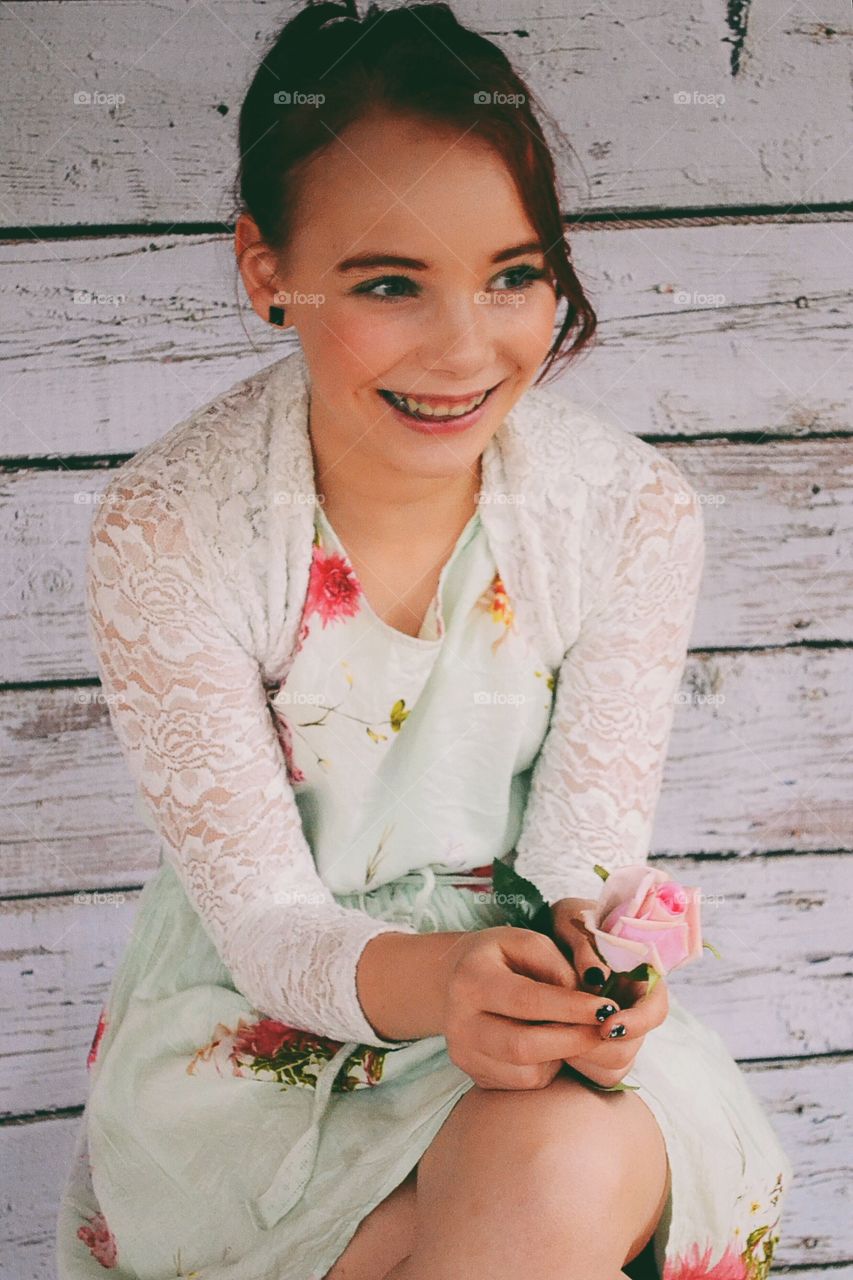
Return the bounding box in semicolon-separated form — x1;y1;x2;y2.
247;867;488;1231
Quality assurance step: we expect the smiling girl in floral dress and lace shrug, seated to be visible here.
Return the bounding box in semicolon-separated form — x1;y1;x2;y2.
58;4;792;1280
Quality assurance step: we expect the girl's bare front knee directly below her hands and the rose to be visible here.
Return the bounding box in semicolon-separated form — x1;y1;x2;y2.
384;1076;669;1280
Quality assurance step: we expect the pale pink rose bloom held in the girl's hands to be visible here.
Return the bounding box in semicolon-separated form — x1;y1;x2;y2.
579;863;702;977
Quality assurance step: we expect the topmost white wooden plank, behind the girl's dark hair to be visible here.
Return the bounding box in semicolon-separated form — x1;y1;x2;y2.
0;0;849;227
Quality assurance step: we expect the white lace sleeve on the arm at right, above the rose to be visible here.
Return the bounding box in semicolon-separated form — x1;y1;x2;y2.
515;454;704;904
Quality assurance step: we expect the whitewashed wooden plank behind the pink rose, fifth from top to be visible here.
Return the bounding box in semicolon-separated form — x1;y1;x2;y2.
0;855;853;1115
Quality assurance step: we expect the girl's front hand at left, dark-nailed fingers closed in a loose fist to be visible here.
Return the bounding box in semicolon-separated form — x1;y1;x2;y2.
442;925;625;1089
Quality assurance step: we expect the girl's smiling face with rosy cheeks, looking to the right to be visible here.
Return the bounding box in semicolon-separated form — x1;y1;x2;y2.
240;116;557;484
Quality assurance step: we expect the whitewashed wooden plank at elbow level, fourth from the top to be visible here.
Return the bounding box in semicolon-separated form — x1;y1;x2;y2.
0;649;853;893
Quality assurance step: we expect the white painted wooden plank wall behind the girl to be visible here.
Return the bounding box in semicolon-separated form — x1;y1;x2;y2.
0;0;853;1280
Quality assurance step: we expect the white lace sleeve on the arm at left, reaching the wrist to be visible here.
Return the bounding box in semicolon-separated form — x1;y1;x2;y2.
86;477;416;1047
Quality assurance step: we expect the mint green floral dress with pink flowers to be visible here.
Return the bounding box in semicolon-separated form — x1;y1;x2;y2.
58;507;790;1280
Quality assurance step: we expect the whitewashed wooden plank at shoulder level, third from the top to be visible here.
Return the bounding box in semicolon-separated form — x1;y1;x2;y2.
0;439;853;681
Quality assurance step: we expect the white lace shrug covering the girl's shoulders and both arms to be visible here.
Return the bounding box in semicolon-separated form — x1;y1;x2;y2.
86;351;703;1046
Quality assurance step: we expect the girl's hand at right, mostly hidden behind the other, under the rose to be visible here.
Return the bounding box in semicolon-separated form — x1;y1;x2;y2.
551;897;670;1085
